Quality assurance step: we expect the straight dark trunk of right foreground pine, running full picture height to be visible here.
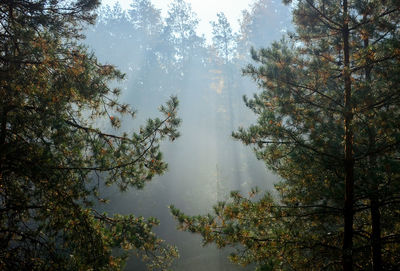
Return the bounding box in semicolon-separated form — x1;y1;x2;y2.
342;0;354;271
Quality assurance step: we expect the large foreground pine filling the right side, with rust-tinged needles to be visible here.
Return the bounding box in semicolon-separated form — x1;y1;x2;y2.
172;0;400;270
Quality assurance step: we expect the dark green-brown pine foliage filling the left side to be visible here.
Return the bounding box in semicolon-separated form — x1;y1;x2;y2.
0;0;179;270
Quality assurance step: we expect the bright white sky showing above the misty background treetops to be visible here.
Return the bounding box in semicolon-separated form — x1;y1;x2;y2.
103;0;254;39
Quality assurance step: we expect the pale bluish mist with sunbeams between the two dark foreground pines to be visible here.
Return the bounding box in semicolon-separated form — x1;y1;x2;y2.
85;0;291;271
